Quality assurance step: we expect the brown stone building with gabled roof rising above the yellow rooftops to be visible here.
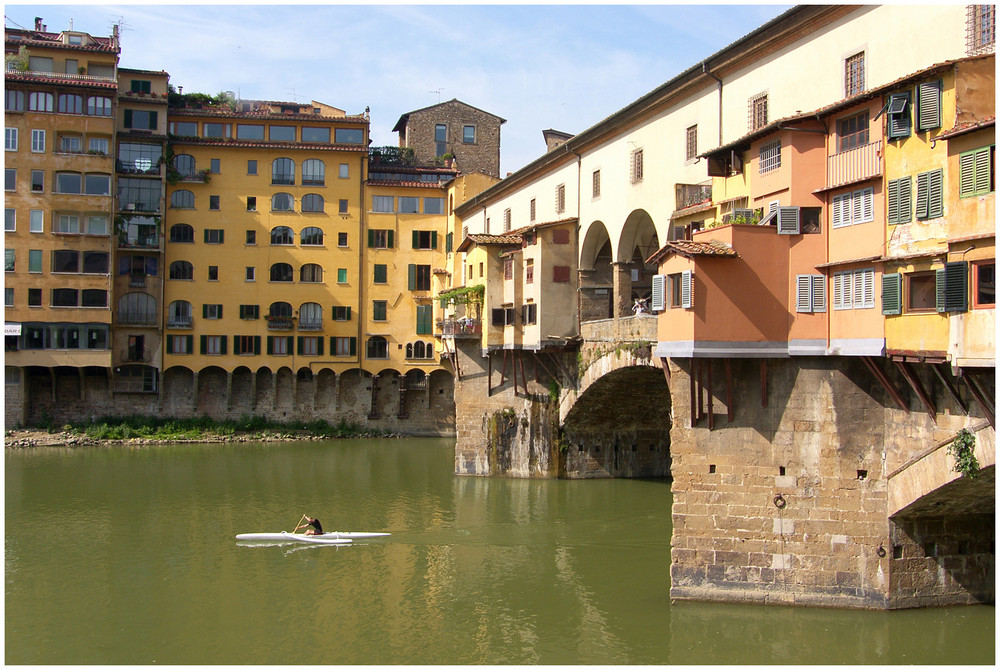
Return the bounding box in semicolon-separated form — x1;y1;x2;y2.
392;99;506;178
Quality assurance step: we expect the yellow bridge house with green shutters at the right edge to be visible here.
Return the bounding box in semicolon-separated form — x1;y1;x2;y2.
881;54;996;367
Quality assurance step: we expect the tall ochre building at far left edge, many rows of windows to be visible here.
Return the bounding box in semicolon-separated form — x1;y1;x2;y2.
4;19;120;406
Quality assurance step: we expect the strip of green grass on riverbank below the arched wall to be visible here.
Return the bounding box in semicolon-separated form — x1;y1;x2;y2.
41;416;385;441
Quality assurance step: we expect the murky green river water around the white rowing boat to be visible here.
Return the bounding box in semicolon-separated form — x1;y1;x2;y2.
4;439;996;665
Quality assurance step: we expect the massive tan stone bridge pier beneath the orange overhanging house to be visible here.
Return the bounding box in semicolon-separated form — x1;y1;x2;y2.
670;358;993;608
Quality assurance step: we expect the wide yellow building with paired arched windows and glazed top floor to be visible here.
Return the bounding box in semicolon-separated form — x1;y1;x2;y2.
164;100;368;384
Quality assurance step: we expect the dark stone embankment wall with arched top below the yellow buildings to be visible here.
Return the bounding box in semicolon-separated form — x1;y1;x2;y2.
5;369;455;437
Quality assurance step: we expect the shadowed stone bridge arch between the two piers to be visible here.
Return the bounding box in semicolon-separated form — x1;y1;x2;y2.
559;342;672;478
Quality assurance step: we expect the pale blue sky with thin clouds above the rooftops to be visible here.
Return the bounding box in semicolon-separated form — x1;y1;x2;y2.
4;3;789;174
